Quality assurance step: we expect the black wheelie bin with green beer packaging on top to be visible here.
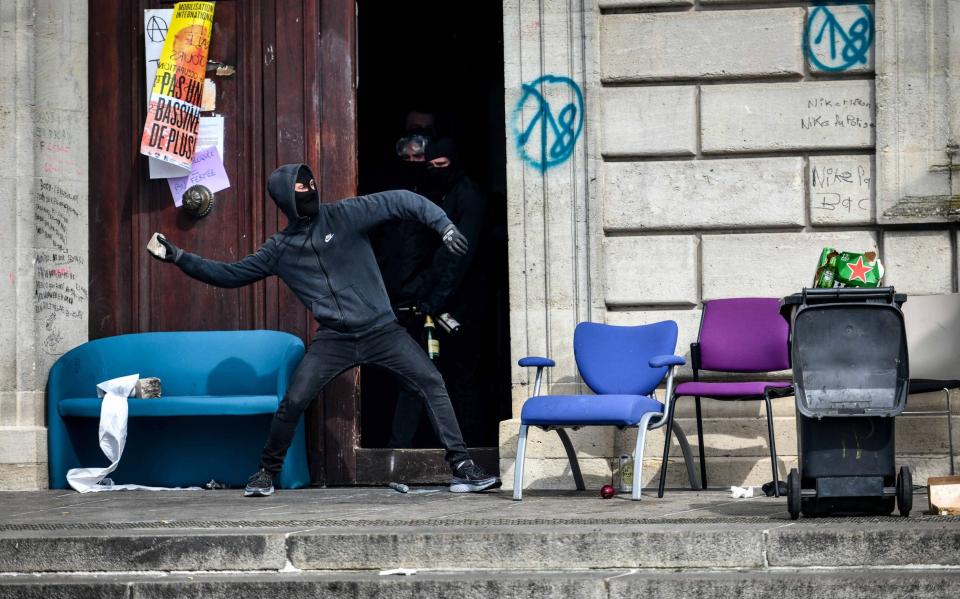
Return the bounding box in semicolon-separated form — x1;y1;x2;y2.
781;287;913;519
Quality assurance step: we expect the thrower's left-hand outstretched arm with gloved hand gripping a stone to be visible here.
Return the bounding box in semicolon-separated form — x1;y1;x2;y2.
150;235;274;288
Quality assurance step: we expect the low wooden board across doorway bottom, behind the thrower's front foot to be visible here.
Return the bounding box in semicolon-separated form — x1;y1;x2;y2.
356;447;500;485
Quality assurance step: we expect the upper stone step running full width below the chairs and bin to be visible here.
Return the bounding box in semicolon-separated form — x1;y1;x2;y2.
0;516;960;581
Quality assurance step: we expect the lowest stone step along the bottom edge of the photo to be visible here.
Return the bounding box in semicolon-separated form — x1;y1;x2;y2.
0;568;960;599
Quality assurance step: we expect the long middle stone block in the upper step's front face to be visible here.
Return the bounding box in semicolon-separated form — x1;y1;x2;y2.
289;523;768;570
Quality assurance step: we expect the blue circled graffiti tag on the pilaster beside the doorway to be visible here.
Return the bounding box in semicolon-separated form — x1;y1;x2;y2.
513;75;583;172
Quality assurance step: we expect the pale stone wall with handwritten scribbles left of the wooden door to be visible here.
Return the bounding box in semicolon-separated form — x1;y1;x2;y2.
0;0;88;490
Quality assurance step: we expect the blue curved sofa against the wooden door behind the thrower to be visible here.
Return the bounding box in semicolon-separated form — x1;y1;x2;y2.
47;331;310;489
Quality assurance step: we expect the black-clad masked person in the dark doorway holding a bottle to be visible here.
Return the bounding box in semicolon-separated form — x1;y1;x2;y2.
389;139;489;447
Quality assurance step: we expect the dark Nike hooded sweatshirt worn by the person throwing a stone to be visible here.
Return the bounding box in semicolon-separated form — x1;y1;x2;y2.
176;164;450;337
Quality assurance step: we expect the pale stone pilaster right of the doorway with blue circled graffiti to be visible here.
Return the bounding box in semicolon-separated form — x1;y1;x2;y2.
500;0;613;487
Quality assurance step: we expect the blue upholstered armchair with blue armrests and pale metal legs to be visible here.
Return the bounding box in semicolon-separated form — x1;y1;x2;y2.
513;320;697;501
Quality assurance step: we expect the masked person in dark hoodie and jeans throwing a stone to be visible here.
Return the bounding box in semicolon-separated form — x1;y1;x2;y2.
151;164;500;496
